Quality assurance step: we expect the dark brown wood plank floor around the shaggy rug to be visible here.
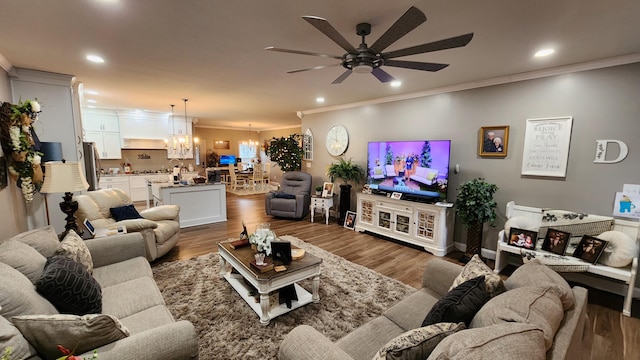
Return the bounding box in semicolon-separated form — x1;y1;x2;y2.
151;193;640;360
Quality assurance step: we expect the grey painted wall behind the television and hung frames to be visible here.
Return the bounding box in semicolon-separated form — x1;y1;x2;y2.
302;64;640;249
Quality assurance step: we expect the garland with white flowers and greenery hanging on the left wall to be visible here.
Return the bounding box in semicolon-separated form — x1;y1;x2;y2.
0;100;44;203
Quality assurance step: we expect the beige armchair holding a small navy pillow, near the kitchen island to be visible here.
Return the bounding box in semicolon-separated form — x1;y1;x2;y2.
73;188;180;261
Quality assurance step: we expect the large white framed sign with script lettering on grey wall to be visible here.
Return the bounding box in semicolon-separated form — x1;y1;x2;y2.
521;116;573;177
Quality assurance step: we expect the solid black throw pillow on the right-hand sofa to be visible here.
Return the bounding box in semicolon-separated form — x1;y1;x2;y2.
422;276;489;326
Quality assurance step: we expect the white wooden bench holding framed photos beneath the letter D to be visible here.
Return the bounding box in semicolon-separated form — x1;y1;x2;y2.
494;201;639;316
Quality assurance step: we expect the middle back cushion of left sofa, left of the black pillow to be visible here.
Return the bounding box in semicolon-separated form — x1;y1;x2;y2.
0;263;58;319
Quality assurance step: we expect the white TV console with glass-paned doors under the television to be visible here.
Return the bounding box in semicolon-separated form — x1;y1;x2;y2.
355;193;455;256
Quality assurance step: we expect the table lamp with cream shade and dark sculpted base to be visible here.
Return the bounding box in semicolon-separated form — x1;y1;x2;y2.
40;160;89;241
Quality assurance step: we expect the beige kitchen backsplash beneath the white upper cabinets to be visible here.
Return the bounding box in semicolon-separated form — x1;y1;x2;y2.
100;149;204;173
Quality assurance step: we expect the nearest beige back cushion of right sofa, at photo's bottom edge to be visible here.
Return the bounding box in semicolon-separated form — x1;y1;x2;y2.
428;323;546;360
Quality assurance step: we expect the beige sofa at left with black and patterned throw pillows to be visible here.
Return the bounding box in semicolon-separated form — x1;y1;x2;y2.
0;227;198;360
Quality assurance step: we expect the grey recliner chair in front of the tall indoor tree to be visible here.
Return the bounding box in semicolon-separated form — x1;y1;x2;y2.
264;171;312;219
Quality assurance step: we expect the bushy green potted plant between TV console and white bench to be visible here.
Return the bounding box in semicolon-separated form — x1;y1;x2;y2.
456;178;498;262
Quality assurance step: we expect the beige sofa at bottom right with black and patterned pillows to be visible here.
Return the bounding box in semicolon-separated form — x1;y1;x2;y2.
278;258;592;360
